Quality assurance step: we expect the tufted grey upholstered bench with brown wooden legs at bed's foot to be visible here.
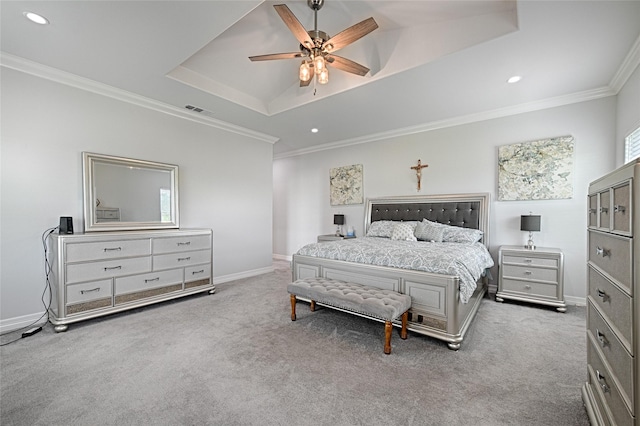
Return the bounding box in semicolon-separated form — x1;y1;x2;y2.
287;277;411;354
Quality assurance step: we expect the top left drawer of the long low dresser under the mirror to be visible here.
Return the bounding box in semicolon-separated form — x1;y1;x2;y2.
66;238;151;263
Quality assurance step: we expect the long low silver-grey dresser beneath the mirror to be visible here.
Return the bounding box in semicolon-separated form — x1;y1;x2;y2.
47;229;215;332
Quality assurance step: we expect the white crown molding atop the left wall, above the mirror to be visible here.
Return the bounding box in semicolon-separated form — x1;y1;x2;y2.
0;51;279;144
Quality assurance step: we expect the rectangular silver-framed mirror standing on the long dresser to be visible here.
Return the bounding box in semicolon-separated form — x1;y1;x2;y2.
82;152;179;232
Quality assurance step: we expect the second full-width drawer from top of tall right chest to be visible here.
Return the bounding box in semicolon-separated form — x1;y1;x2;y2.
588;265;633;352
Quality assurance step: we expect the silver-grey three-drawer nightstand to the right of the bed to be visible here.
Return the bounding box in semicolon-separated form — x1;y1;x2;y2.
496;246;567;312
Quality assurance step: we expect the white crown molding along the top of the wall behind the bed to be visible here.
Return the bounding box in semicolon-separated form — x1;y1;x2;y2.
273;87;617;160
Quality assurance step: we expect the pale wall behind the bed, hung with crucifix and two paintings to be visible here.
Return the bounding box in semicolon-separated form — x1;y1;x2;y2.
273;97;616;303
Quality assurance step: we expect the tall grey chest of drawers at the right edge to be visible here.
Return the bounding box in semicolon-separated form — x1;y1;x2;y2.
582;161;640;426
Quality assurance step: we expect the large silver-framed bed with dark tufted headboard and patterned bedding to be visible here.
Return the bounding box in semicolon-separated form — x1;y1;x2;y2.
292;193;493;350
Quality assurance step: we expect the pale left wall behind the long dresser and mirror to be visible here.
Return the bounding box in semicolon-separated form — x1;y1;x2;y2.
0;68;273;328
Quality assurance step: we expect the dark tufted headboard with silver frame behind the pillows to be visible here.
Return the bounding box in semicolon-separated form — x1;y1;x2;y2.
364;193;490;247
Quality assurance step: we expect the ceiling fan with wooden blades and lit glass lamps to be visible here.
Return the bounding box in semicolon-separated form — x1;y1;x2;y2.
249;0;378;87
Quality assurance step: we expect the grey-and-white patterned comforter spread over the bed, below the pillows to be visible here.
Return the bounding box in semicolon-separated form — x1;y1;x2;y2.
297;237;493;303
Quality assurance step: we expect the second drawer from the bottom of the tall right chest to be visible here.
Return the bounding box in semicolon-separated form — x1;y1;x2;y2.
587;303;635;401
